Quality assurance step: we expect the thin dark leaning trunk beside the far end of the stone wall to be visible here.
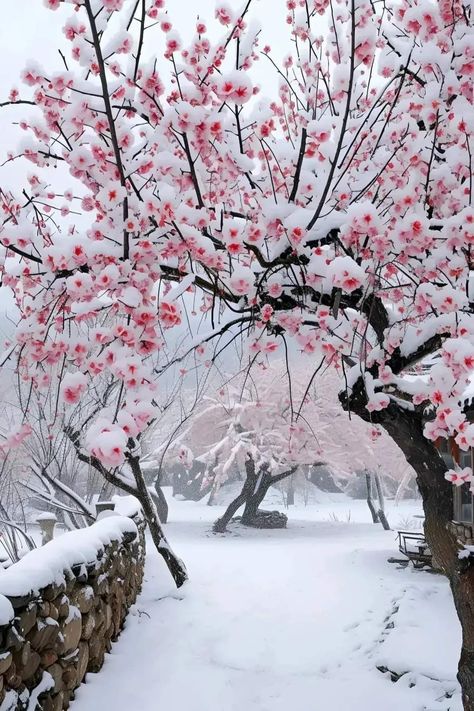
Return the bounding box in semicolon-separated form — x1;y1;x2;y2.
129;457;188;588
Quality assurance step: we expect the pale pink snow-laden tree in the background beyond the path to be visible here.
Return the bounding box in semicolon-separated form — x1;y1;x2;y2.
166;364;408;531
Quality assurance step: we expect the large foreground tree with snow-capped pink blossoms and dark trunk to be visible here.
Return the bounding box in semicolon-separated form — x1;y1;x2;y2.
0;0;474;700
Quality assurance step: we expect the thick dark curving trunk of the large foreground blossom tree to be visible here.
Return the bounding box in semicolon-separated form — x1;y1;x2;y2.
341;388;474;711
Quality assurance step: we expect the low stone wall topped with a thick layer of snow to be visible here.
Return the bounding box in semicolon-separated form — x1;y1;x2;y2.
0;513;145;711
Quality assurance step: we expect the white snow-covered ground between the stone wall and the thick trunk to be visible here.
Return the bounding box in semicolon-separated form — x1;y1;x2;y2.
72;495;461;711
